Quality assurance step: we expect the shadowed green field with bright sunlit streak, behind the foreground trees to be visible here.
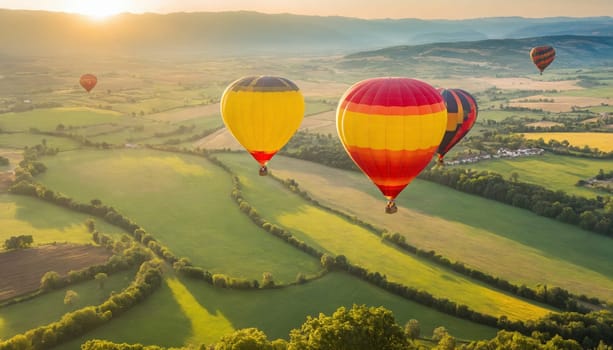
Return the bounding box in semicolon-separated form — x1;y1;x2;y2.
58;272;496;349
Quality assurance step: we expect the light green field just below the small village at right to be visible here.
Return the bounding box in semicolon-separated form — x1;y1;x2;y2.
470;152;613;198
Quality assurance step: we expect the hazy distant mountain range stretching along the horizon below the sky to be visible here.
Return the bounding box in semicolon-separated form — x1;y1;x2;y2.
0;10;613;57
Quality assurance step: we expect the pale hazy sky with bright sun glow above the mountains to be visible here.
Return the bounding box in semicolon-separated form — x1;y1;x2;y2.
0;0;613;19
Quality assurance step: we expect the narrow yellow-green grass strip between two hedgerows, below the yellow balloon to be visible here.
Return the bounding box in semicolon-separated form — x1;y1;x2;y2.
214;153;551;319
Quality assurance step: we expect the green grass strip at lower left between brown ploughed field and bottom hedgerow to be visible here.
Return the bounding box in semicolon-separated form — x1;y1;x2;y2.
0;271;134;340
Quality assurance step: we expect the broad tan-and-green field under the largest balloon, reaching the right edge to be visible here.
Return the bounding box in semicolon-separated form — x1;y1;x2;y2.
271;157;613;300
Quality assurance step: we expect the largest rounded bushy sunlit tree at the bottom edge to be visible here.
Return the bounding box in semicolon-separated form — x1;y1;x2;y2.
288;305;409;350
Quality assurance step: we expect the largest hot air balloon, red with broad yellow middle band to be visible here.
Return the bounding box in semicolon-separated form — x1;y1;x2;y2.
336;78;447;214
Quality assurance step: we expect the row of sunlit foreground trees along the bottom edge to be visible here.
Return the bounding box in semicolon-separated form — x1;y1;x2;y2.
81;305;613;350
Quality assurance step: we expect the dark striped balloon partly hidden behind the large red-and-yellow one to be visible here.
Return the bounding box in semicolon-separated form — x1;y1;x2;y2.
437;89;478;165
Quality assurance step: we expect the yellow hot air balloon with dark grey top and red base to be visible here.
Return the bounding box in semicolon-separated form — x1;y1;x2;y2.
221;76;304;176
